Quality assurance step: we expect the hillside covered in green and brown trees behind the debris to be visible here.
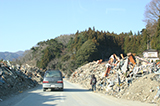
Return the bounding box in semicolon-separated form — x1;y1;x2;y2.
16;27;158;75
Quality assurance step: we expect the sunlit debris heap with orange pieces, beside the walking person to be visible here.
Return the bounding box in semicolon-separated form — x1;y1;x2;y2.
69;53;160;103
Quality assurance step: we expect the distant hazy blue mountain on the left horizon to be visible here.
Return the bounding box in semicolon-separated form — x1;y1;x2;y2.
0;51;24;61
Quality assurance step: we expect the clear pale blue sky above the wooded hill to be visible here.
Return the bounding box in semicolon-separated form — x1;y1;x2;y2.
0;0;151;52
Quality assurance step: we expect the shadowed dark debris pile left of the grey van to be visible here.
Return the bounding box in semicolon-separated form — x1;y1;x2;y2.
0;62;44;102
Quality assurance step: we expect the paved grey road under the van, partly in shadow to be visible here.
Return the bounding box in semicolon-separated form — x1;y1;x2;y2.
0;81;156;106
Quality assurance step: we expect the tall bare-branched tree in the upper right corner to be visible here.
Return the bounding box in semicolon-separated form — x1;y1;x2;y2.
144;0;160;37
